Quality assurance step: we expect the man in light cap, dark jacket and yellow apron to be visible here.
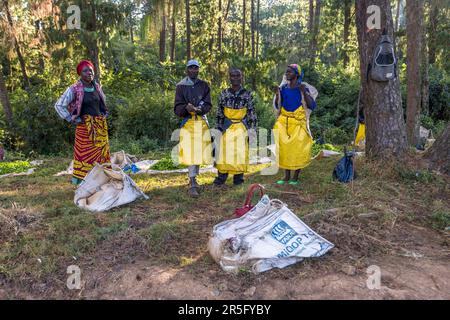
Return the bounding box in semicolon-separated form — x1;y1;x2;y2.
174;60;213;197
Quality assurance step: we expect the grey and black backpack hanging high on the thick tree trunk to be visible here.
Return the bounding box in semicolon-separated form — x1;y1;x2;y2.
369;32;397;82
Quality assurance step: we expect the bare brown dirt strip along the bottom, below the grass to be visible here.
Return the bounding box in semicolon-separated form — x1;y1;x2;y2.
0;205;450;300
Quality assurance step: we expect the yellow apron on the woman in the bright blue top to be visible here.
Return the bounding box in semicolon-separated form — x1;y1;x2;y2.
273;106;313;170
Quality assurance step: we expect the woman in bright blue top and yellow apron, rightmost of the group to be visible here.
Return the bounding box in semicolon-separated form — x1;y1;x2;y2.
273;64;316;185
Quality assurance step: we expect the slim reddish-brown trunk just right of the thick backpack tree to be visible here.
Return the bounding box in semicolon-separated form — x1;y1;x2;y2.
406;0;423;146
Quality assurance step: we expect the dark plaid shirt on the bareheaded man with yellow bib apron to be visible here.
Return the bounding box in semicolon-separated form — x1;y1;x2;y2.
217;87;258;129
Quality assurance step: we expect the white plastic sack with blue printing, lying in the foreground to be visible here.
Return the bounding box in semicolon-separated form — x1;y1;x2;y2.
208;195;334;273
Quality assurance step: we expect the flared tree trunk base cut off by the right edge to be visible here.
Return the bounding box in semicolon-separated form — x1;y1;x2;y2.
424;122;450;174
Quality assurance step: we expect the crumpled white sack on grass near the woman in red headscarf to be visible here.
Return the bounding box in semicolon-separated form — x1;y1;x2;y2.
74;164;148;212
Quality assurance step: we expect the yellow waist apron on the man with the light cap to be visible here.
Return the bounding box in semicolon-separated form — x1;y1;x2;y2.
179;113;213;166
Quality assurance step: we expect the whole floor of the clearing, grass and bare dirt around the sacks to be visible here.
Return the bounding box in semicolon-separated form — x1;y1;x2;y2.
0;156;450;300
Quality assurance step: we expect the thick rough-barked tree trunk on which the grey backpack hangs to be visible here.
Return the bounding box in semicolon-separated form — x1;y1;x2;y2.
356;0;407;159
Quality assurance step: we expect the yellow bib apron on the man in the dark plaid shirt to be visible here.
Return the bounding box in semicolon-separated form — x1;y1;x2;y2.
216;107;249;175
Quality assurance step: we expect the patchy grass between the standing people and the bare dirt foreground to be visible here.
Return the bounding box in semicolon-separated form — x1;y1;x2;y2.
0;153;450;292
